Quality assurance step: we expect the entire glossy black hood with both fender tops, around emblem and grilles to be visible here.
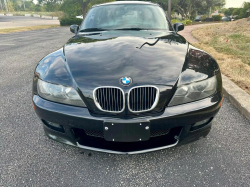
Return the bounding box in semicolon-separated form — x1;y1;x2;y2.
33;31;219;114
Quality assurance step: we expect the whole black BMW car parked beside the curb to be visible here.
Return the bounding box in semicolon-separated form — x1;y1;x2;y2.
32;1;223;154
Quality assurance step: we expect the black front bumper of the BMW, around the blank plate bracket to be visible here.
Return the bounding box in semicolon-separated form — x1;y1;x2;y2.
33;93;223;154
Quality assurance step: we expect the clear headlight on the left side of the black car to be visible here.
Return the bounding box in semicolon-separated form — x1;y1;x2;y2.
37;79;86;107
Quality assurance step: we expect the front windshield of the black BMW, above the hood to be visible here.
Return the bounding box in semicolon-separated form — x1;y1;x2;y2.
80;4;172;32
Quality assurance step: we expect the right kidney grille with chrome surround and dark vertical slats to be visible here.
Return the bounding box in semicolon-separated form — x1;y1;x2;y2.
128;85;160;113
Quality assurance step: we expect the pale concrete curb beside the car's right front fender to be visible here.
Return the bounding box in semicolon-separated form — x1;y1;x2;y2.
222;75;250;121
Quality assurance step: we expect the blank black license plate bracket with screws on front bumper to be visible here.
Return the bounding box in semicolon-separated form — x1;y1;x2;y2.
103;121;150;142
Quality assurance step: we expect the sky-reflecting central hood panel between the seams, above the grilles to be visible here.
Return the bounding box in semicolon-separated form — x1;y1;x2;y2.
64;31;188;89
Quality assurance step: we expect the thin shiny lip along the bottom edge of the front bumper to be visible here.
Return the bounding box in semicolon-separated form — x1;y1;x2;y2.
76;139;179;155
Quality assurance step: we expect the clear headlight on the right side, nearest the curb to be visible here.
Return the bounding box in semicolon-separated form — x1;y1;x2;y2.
168;76;217;106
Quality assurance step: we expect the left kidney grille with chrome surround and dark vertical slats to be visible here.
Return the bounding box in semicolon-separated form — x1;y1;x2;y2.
93;86;125;113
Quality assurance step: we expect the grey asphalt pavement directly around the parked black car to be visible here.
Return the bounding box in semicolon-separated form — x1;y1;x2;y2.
0;27;250;186
